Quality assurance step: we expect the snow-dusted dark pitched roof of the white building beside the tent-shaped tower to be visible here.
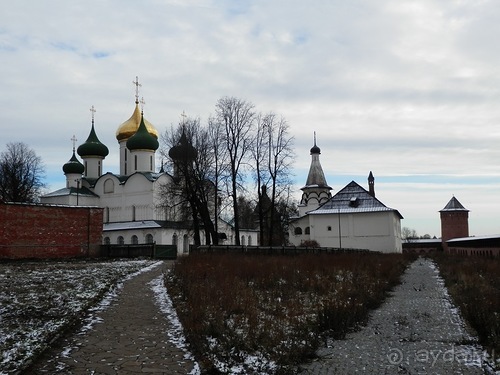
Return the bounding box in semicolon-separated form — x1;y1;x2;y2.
309;181;403;219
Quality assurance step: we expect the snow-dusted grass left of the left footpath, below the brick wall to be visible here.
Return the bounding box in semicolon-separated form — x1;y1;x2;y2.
0;260;155;375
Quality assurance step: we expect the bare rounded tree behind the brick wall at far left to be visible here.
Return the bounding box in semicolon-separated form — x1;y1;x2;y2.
0;142;45;202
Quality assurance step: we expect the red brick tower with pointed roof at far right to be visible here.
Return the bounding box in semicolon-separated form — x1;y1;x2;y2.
439;196;469;248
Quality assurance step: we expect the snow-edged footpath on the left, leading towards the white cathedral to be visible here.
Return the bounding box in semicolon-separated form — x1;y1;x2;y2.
25;262;199;375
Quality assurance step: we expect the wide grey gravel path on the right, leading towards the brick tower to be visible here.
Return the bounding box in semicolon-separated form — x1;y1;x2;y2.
301;259;485;375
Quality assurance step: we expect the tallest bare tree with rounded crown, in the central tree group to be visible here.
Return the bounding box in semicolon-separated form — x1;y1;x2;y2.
215;97;255;245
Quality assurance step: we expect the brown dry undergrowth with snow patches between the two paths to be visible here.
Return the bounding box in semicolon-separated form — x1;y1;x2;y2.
166;253;409;374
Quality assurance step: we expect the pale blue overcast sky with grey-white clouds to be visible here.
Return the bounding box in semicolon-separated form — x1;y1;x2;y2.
0;0;500;237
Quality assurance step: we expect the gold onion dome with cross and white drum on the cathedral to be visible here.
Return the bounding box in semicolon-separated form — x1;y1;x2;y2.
116;77;158;175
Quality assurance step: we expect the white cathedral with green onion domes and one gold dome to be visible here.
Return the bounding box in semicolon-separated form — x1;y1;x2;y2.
41;80;258;254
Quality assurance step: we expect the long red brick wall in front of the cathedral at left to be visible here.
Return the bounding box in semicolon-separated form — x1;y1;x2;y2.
0;203;103;259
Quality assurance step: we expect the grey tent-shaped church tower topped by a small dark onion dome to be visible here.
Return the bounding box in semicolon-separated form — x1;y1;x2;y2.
299;132;332;216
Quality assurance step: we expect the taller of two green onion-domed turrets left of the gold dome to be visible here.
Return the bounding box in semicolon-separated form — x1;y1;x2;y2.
77;106;109;178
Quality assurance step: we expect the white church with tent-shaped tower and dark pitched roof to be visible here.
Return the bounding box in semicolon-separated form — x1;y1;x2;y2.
289;138;403;253
